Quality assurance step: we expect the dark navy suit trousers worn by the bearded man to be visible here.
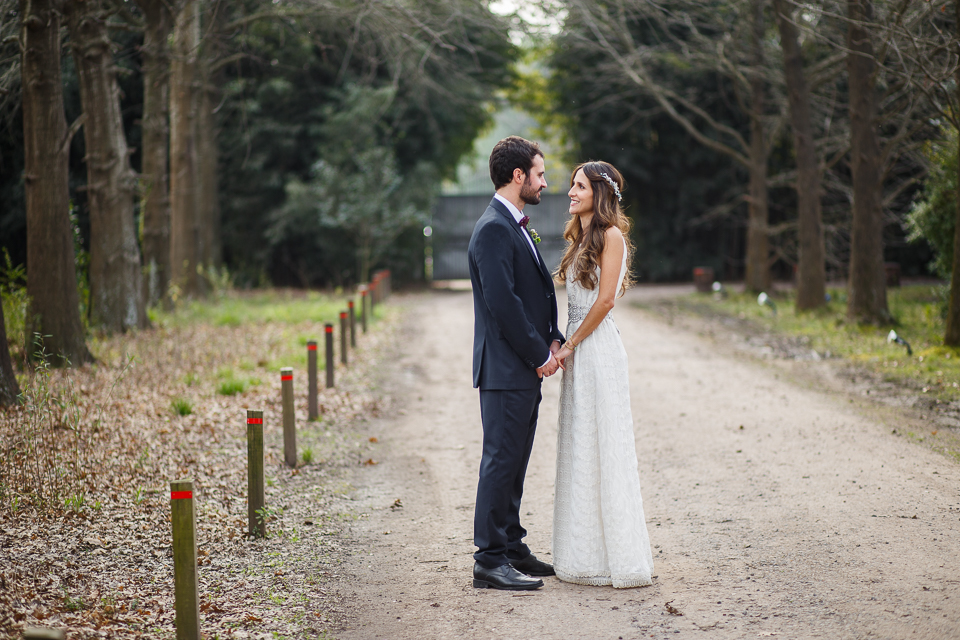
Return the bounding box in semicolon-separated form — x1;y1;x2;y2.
473;386;542;569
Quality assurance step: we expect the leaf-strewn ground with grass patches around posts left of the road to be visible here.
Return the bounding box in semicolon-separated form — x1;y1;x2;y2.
0;291;399;638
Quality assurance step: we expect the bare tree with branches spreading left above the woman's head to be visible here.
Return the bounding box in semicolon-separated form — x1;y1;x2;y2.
565;0;783;291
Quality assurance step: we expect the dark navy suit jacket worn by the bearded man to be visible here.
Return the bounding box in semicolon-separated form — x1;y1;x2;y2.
467;198;564;389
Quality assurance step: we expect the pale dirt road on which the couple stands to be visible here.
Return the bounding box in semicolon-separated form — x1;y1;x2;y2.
337;290;960;640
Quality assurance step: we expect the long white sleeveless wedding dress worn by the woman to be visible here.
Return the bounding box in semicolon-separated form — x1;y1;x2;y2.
553;240;653;588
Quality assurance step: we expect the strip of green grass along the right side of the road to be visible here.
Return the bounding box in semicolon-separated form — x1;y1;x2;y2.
668;284;960;400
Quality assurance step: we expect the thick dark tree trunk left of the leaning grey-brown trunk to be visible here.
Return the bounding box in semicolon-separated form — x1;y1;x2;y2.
20;0;93;366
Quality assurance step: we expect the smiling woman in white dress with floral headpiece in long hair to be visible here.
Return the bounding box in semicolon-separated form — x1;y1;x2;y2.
553;162;653;588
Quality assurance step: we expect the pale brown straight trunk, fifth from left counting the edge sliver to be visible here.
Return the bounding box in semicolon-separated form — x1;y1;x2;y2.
170;0;203;297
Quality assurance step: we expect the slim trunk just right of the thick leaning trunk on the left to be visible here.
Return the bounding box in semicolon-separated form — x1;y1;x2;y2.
137;0;173;305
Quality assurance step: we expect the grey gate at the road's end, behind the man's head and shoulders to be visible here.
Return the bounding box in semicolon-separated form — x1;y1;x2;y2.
431;193;570;280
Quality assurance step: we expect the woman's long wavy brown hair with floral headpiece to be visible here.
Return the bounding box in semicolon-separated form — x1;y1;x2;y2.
554;160;633;296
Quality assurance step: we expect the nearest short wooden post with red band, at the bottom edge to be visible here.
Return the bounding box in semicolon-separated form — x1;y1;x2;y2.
170;480;200;640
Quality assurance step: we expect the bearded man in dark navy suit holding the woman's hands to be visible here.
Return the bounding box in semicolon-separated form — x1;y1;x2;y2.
467;136;564;590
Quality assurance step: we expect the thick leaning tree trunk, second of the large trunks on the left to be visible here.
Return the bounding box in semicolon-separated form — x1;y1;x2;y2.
66;0;147;332
